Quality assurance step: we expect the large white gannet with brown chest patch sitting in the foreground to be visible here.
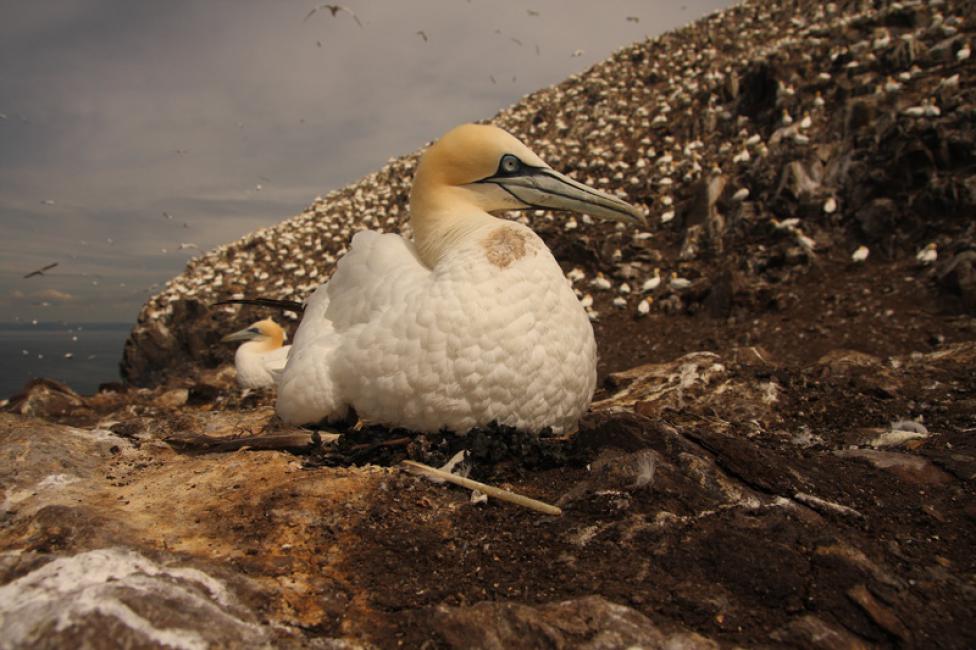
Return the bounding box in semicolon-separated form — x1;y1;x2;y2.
277;124;644;432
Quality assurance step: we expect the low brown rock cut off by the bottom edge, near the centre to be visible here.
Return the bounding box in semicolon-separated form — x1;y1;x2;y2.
433;596;719;650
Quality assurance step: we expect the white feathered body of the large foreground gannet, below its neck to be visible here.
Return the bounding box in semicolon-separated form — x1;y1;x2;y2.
277;220;596;432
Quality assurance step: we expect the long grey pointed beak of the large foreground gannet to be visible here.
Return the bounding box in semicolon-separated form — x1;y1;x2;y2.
478;165;647;226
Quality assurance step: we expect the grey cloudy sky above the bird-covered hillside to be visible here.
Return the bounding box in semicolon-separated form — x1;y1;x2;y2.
0;0;731;322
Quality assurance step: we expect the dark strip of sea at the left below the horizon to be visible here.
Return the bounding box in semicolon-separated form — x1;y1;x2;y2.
0;323;132;399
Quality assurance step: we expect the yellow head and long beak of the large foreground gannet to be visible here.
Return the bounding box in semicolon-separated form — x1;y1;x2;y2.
410;124;645;225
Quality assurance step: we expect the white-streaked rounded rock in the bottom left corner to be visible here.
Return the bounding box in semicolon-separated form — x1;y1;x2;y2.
0;548;272;648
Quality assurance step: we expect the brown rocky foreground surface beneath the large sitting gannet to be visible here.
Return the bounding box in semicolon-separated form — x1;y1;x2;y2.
0;343;976;648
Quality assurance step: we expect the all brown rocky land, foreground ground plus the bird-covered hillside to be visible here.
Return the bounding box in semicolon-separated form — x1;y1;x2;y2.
0;1;976;648
